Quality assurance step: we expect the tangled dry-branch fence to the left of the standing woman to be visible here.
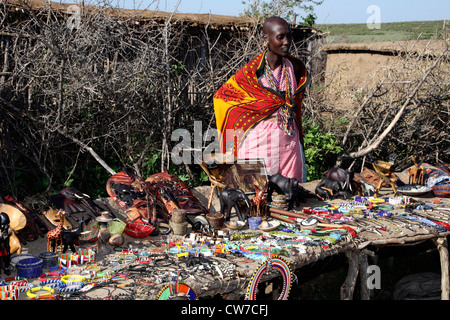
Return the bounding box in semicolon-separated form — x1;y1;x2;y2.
0;0;316;200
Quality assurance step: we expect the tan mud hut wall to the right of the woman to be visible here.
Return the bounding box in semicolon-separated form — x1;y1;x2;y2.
322;40;450;110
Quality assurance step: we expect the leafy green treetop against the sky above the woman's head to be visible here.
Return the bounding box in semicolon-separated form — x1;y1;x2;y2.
242;0;323;25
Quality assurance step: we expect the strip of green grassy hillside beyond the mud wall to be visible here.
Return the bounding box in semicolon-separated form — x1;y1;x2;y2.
314;20;448;42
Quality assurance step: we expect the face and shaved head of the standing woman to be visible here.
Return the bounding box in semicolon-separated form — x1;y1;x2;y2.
265;21;292;57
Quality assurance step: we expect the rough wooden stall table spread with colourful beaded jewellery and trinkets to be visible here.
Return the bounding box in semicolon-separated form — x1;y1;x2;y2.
1;185;449;300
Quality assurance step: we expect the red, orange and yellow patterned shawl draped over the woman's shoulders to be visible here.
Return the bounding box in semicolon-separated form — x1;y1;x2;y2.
214;51;310;156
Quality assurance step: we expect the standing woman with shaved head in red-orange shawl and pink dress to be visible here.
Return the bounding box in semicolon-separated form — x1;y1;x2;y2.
214;17;310;182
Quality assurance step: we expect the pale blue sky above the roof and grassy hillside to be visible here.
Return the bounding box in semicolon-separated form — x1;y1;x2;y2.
71;0;450;23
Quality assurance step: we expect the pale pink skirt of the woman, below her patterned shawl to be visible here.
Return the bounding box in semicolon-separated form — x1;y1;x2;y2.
237;120;307;182
